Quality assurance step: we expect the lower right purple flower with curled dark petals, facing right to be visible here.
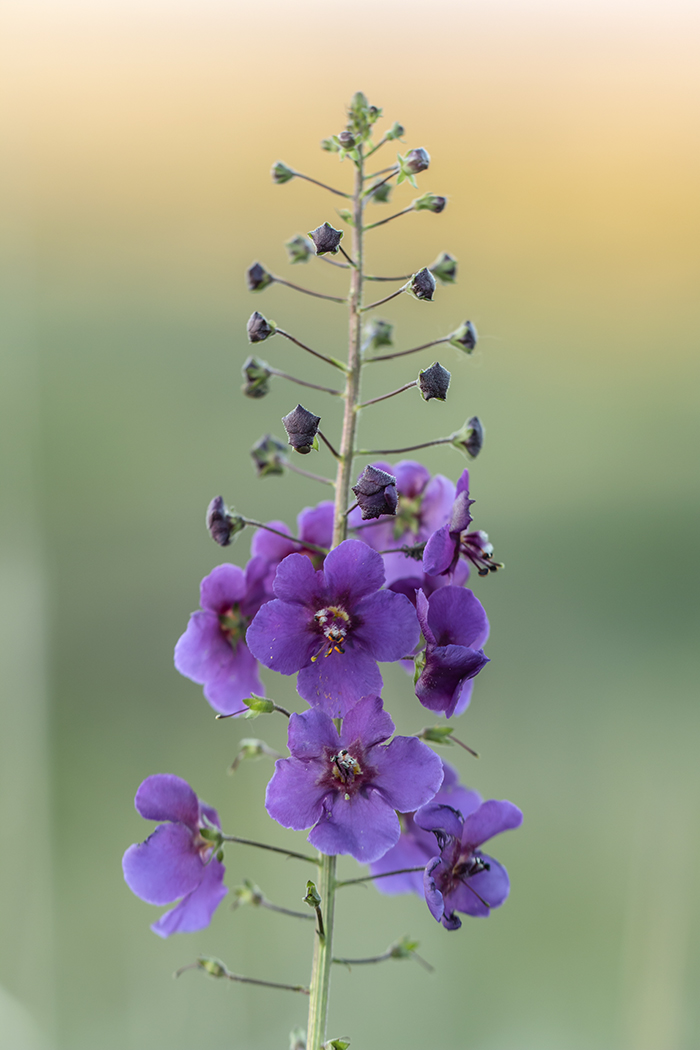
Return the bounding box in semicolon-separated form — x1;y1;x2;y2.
415;799;523;929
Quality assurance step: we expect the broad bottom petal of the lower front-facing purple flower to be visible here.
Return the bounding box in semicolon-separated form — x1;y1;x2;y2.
309;789;401;864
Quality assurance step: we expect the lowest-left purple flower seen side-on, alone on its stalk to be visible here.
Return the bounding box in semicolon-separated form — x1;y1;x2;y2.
122;773;228;937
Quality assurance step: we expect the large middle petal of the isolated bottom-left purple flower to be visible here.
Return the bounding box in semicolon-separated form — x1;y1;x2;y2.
122;824;204;904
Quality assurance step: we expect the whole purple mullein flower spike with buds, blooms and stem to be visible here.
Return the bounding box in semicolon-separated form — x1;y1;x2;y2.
123;92;523;1050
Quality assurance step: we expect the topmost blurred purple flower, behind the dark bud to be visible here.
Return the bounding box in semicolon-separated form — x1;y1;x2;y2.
348;460;454;587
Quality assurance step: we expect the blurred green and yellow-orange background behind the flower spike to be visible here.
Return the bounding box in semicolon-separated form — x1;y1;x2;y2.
0;0;700;1050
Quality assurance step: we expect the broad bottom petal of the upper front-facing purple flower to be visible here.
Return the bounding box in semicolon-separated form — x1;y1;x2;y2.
295;642;383;718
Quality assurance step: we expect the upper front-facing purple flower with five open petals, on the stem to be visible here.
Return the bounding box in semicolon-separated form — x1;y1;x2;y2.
246;540;420;718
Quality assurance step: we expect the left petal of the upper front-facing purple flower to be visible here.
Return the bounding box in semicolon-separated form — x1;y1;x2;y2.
246;600;319;674
